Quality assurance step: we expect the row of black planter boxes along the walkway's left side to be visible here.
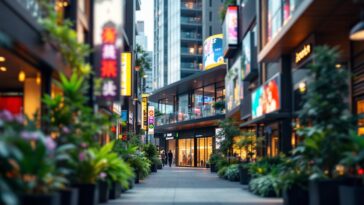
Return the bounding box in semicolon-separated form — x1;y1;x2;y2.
20;180;133;205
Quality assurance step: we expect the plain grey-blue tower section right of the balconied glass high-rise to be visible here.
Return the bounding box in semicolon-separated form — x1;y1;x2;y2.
202;0;225;39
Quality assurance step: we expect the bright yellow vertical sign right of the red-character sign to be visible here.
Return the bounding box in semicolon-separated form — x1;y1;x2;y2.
121;52;131;96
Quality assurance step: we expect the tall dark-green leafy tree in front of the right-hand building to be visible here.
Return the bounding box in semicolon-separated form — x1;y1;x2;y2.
294;46;354;178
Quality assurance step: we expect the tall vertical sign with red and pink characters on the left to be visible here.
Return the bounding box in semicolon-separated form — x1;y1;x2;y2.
98;26;120;101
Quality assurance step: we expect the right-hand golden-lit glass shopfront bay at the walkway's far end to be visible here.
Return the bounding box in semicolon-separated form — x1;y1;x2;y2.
196;137;212;167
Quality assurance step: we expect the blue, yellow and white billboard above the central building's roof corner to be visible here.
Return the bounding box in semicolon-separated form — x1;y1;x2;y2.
203;34;225;70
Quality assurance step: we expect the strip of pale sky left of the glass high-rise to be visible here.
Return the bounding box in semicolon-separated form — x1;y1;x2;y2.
136;0;154;51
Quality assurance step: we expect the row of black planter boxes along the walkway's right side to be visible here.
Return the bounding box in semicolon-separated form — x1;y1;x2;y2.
210;164;364;205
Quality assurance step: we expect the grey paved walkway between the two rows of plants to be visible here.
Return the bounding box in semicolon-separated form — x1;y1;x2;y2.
107;167;282;205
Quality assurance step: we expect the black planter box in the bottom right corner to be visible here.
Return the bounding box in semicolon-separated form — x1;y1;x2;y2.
339;186;364;205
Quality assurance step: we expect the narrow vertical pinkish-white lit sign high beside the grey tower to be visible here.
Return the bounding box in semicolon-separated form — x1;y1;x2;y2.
224;6;238;45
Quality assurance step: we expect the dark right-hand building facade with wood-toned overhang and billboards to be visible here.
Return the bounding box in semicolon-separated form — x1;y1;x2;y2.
225;0;363;159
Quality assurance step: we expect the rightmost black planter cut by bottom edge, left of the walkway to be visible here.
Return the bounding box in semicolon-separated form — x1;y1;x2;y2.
74;184;99;205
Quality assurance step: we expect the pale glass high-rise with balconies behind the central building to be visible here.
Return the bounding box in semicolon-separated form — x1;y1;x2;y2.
154;0;203;88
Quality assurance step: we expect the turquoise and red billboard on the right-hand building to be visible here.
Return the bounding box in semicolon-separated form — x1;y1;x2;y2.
252;74;281;119
